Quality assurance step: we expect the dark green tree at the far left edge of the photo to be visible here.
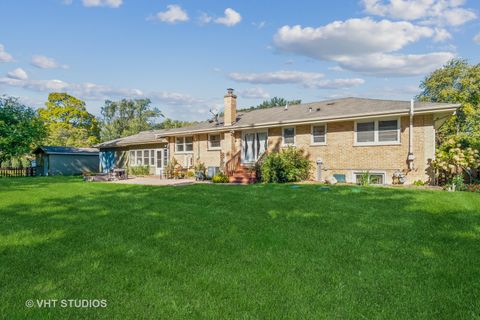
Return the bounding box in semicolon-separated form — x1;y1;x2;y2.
0;97;46;165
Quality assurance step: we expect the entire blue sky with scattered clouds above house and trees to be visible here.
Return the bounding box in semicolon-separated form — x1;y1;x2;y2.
0;0;480;120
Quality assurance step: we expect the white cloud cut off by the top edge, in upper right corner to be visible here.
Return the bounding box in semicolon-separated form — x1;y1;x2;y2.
362;0;477;26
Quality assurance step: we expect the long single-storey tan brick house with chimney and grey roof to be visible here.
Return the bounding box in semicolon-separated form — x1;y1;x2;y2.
98;89;459;184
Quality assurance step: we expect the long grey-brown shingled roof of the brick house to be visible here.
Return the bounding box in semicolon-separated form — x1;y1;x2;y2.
98;97;460;147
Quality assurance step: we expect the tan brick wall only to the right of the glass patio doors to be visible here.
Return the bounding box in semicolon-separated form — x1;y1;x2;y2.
268;115;435;183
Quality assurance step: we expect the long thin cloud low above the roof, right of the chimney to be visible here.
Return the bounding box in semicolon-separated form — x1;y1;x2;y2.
228;70;365;89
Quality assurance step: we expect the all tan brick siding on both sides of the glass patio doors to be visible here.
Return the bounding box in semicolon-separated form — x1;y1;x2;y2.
164;115;435;183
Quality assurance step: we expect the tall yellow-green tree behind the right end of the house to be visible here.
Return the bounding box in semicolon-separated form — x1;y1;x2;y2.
418;59;480;148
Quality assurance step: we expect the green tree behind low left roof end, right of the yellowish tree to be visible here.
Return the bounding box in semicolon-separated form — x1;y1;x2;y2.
101;99;163;141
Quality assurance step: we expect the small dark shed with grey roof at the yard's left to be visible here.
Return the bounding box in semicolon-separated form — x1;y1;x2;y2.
33;146;99;176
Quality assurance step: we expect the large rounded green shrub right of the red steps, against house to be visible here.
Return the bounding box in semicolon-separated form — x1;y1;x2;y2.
260;147;312;183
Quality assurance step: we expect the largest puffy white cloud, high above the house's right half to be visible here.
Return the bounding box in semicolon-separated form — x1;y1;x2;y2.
274;18;434;59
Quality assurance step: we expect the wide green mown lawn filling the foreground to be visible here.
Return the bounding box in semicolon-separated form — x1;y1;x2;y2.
0;178;480;319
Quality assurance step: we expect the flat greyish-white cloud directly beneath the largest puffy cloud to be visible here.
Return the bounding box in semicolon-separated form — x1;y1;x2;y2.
338;52;455;77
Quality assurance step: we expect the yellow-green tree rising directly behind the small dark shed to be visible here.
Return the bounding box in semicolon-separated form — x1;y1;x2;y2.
38;93;100;147
